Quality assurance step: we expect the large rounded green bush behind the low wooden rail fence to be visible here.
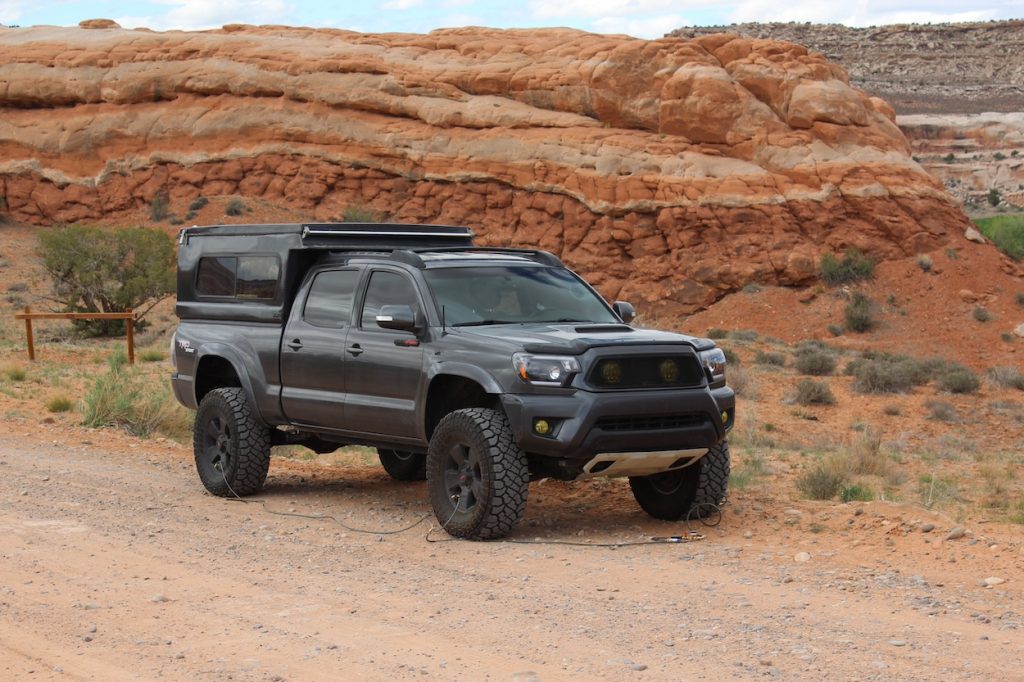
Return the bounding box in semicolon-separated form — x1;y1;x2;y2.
38;225;175;336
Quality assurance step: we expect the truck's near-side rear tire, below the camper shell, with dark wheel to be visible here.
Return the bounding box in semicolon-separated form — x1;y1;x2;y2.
193;388;270;498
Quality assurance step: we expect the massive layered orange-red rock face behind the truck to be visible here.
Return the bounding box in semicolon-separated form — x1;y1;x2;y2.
0;23;967;312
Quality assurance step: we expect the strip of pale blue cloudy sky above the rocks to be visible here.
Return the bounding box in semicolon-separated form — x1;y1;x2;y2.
0;0;1024;38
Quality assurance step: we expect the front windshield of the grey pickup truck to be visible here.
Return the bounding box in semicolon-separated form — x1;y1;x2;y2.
424;265;618;327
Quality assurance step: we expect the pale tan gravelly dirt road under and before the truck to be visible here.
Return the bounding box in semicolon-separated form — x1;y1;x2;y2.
0;421;1024;680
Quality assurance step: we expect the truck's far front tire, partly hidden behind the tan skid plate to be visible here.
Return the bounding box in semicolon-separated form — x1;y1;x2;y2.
630;440;729;521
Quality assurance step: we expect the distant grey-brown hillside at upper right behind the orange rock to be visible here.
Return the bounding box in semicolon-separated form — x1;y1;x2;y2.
669;19;1024;114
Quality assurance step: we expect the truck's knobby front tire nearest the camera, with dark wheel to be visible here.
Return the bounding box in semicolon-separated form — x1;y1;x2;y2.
427;408;529;540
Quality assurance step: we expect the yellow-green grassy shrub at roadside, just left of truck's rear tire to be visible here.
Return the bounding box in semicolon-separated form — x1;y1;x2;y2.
82;350;193;440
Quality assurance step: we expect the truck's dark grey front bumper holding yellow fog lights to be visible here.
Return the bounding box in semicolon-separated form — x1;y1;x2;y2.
502;387;736;461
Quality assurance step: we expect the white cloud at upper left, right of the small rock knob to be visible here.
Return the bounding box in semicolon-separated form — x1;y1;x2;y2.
115;0;295;31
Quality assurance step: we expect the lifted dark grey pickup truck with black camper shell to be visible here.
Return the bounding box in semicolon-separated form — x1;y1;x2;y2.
171;223;735;540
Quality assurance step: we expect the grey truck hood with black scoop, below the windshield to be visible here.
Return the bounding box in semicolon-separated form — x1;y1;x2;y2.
459;323;715;355
